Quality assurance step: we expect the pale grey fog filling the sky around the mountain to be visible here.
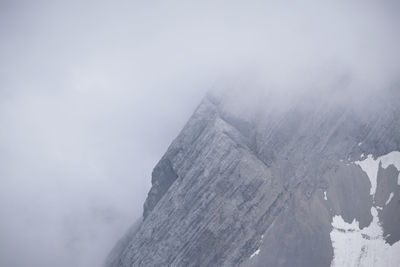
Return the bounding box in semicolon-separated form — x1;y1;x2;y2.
0;0;400;267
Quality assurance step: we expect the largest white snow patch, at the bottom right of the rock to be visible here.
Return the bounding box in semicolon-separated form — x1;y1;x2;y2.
330;207;400;267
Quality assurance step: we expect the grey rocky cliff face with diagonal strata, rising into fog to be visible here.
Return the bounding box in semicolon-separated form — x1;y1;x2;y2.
107;90;400;266
